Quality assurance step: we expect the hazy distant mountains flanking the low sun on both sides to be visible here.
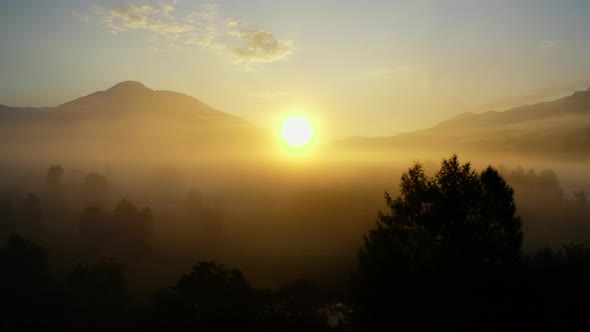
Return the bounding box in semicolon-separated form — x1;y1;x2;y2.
0;81;590;160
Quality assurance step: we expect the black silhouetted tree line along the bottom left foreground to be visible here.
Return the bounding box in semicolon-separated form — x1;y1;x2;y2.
0;235;345;331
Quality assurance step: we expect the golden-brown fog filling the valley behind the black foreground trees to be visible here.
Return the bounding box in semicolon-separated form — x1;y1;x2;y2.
0;147;590;298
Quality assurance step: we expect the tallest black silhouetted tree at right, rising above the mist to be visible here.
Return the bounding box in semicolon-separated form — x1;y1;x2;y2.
355;155;522;330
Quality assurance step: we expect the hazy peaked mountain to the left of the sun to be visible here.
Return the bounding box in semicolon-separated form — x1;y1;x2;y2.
0;81;265;163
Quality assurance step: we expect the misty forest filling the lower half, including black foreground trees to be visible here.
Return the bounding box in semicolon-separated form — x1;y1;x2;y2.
0;155;590;331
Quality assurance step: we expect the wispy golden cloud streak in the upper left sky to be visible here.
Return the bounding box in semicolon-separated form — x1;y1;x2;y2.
74;1;294;69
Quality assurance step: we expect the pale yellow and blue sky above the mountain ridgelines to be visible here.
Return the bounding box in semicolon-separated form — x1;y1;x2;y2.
0;0;590;138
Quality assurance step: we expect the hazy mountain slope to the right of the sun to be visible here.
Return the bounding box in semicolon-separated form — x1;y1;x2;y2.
337;89;590;160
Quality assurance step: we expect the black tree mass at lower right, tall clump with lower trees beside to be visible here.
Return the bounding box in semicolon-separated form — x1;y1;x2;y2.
352;156;590;331
